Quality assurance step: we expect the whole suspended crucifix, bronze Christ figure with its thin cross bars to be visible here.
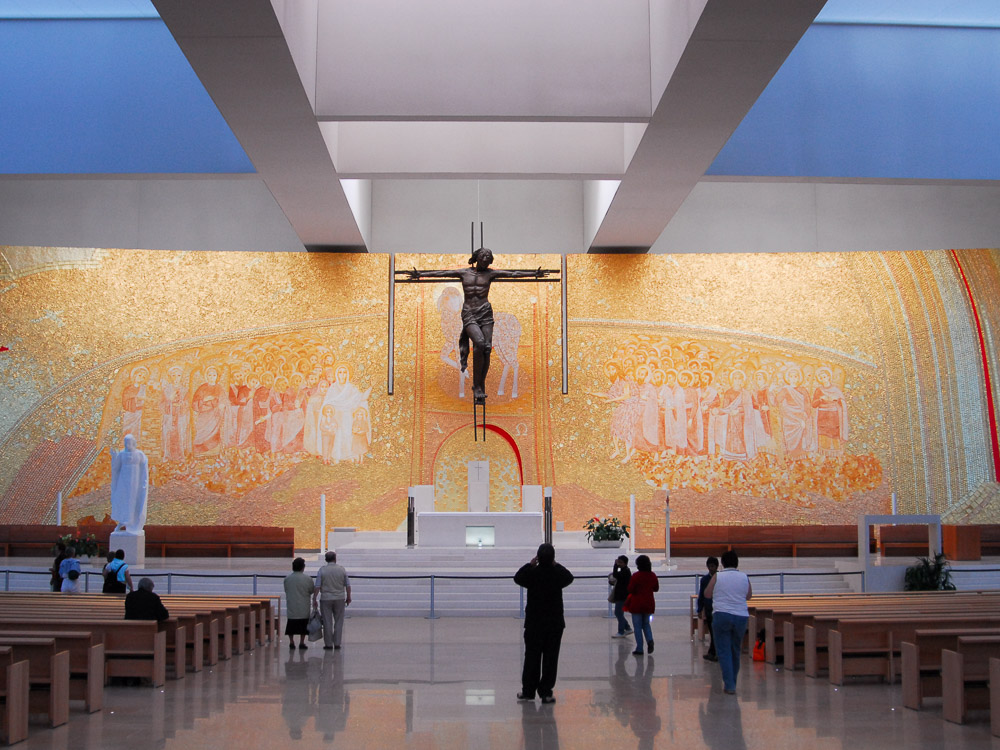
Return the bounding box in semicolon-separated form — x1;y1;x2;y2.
390;223;565;440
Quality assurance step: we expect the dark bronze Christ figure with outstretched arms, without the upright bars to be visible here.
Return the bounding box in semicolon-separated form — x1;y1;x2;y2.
408;247;550;404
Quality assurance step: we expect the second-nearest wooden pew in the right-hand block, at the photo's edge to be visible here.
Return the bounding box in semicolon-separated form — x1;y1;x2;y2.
941;635;1000;724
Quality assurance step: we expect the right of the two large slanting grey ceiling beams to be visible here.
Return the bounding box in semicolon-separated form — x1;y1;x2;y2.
590;0;825;252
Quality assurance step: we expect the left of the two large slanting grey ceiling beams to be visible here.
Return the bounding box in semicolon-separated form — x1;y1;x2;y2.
153;0;365;250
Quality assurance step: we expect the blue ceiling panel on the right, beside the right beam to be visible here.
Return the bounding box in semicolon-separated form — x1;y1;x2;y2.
708;23;1000;180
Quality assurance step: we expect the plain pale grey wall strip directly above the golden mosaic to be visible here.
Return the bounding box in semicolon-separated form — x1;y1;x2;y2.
0;177;1000;253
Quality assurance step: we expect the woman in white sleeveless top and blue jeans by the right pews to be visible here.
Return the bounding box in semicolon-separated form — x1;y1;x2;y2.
705;550;753;695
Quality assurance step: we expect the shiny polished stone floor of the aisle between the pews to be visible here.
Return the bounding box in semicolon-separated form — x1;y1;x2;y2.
20;617;1000;750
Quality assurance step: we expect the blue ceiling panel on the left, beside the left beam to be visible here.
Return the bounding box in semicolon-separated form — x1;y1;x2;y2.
0;18;254;174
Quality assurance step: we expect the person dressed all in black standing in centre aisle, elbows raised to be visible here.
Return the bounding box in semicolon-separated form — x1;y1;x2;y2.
514;544;573;703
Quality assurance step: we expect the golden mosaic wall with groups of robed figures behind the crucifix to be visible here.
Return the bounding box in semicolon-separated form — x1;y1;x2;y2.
0;247;1000;546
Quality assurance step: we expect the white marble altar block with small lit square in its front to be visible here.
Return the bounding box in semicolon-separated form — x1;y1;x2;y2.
417;513;542;548
